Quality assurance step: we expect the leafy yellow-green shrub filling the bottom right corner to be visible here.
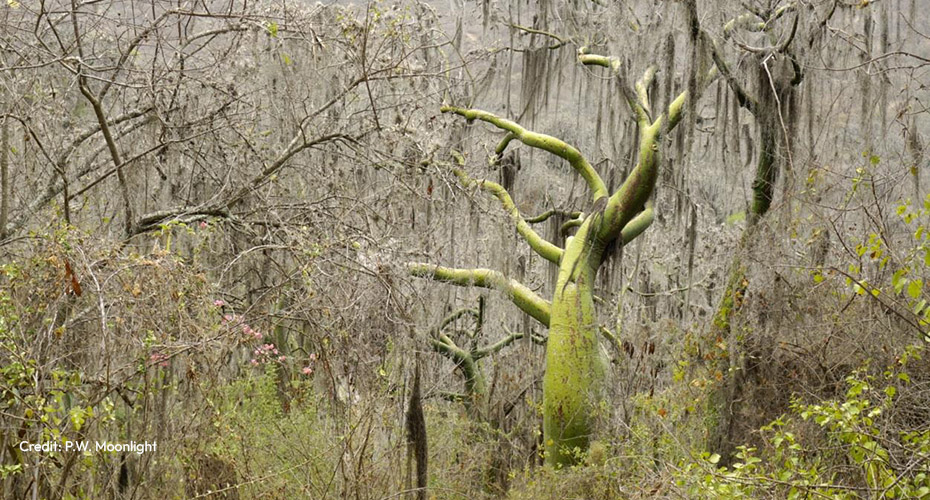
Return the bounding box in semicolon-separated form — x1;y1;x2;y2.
678;348;930;499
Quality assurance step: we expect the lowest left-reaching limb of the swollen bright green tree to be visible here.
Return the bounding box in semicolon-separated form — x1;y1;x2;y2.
407;262;551;327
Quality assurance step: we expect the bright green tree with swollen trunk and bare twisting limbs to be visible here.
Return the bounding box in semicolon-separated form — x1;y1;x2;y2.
408;44;713;466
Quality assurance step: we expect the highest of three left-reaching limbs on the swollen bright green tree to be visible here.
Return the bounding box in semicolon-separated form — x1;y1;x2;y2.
440;106;607;200
